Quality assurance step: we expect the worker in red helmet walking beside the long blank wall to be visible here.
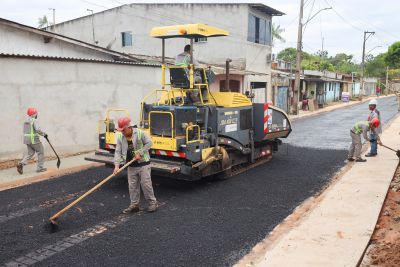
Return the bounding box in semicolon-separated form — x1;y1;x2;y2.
17;107;47;174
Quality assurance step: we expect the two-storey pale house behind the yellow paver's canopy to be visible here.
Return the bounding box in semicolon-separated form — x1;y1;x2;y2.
49;3;283;102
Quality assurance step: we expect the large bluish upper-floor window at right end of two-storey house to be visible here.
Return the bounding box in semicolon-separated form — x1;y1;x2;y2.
247;14;271;45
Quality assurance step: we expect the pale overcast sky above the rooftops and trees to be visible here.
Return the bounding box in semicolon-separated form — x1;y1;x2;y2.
0;0;400;62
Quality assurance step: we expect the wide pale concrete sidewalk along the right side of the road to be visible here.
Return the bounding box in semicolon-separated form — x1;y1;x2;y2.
237;110;400;266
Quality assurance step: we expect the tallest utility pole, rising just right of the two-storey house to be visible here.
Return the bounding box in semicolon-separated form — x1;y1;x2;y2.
293;0;304;115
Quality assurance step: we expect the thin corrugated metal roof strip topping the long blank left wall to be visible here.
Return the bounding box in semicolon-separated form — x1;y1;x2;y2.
0;53;161;68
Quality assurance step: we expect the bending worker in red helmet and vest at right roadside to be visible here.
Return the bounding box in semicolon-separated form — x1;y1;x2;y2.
347;118;382;162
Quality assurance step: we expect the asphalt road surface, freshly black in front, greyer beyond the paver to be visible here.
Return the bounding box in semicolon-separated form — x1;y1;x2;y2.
0;97;397;266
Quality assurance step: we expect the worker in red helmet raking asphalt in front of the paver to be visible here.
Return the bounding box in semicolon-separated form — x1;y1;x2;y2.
114;117;157;213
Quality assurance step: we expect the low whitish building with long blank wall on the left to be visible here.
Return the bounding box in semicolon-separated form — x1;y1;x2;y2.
0;19;161;161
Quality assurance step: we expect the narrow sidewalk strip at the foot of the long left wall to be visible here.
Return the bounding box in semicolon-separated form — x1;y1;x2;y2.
0;152;102;191
